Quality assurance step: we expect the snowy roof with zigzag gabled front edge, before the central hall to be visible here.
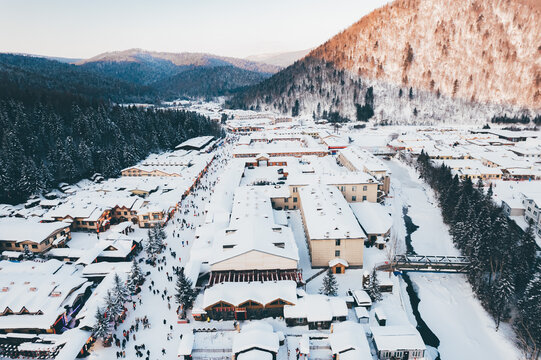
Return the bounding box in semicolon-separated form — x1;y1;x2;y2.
202;280;297;309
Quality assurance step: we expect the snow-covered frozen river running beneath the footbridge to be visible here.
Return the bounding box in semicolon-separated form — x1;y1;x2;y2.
386;160;521;360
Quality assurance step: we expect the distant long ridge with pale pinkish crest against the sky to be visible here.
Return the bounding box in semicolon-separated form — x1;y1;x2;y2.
77;49;281;84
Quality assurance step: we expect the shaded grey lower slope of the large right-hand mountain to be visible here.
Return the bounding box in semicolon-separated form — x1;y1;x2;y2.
226;57;535;125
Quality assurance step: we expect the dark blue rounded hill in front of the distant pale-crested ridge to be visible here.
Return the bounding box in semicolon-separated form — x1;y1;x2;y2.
151;66;270;98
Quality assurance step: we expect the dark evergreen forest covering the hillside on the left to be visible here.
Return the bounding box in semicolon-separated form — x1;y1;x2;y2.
0;56;222;203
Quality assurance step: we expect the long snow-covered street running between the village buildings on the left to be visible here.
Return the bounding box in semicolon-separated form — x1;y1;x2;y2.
88;143;229;359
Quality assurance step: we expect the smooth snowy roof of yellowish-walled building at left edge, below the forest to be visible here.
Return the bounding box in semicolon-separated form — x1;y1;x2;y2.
0;217;69;243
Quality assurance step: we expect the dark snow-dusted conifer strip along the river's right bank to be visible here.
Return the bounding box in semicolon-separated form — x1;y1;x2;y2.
417;152;541;359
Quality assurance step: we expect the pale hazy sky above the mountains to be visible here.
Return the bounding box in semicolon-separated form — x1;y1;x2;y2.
0;0;388;58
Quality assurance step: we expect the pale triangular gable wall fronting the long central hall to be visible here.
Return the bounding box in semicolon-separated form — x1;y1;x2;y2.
211;250;297;271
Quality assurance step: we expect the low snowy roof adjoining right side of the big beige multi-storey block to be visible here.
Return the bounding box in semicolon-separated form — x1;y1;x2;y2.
349;201;393;234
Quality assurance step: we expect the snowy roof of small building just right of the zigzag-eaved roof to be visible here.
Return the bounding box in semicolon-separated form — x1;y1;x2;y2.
284;294;348;322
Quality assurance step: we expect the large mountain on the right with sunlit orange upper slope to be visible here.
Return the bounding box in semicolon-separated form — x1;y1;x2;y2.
229;0;541;123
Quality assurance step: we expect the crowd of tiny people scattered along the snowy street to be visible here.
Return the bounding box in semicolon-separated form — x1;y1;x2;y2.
91;141;234;360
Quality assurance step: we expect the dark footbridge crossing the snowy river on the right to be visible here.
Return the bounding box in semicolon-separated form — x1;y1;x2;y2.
377;255;471;273
